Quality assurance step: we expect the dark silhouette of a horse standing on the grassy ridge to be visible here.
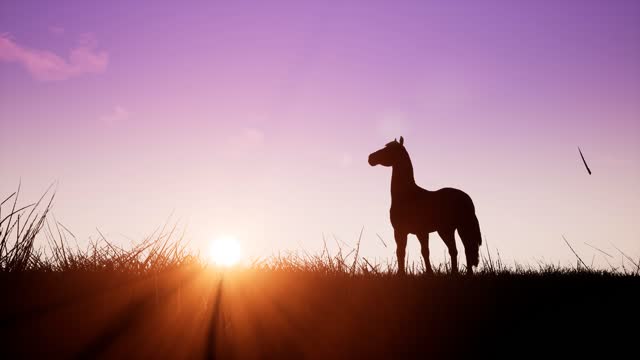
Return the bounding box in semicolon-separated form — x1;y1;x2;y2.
369;136;482;274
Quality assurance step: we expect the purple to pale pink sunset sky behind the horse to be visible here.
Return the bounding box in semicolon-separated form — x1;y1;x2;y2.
0;1;640;264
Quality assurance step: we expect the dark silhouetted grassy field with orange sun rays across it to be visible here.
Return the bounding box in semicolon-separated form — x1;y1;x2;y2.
0;190;640;359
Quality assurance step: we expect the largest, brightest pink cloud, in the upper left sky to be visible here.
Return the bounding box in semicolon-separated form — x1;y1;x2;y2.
0;34;109;81
